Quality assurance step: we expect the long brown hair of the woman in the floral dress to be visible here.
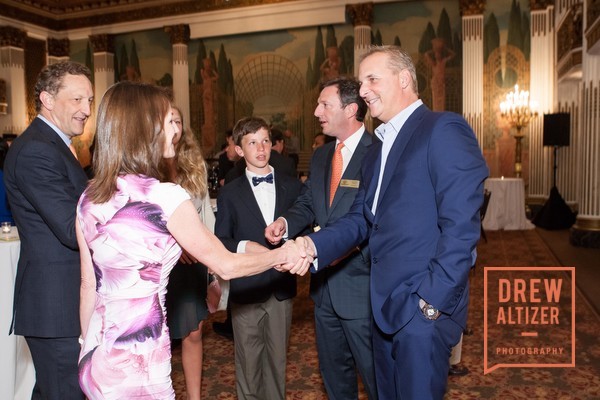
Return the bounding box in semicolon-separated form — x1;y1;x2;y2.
88;81;171;203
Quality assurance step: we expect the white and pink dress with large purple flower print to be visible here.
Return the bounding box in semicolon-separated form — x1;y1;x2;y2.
77;175;189;400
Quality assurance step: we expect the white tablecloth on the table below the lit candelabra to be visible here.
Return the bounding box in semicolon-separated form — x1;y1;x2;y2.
483;178;535;231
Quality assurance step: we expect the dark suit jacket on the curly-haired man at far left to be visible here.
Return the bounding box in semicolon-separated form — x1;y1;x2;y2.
4;118;87;337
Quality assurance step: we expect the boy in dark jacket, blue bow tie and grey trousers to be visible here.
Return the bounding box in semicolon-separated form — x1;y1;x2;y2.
215;117;303;400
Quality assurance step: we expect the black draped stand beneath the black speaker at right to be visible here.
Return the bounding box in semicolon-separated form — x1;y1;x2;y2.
532;146;576;230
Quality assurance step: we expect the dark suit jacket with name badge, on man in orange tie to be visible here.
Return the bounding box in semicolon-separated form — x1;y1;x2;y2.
283;132;378;319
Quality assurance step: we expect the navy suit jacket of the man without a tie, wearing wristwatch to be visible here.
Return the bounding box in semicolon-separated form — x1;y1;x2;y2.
310;105;488;334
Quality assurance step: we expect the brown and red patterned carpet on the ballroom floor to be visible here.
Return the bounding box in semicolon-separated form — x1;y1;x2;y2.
172;230;600;400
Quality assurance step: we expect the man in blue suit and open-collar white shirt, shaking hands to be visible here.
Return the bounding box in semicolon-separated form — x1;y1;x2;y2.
297;46;488;400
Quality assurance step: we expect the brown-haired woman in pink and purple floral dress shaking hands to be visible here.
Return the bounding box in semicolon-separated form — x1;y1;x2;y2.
77;82;311;400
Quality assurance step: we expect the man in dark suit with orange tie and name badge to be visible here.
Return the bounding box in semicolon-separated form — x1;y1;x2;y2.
265;78;377;400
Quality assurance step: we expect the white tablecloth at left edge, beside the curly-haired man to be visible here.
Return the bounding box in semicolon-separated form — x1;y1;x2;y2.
0;227;35;400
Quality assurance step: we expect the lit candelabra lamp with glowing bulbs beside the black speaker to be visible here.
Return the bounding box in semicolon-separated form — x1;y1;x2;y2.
500;85;537;178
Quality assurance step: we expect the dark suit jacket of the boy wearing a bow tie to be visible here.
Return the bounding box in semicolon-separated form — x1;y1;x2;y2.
215;171;304;304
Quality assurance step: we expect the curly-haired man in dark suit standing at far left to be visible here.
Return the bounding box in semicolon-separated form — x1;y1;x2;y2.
4;62;94;400
